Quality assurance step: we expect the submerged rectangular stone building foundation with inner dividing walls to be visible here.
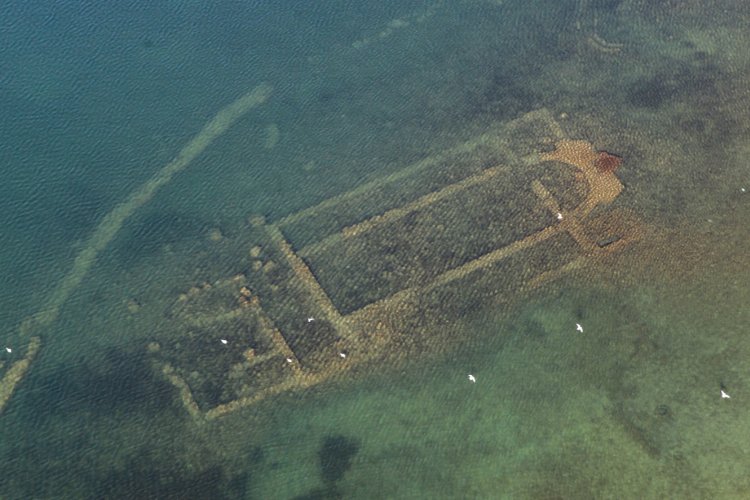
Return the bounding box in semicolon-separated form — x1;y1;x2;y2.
152;109;640;421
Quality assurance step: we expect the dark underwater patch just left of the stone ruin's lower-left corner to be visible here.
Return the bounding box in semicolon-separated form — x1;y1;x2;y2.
20;348;174;419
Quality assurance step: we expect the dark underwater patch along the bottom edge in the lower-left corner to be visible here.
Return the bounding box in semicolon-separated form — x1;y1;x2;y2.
0;418;264;500
